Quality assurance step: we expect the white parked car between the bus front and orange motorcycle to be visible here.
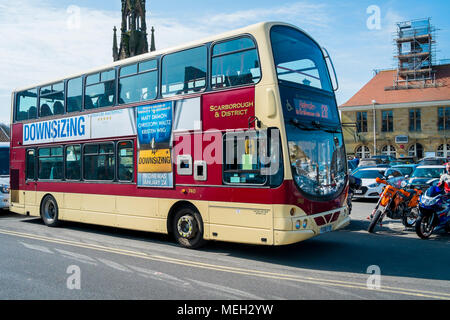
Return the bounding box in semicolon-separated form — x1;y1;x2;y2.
352;167;389;199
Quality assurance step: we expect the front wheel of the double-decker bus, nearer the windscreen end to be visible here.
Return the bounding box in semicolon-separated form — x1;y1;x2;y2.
173;208;206;249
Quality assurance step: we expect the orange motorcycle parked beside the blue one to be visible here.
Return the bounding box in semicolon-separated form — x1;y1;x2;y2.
368;178;422;233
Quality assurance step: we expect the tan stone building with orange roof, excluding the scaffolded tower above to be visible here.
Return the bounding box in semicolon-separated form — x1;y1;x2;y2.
339;64;450;158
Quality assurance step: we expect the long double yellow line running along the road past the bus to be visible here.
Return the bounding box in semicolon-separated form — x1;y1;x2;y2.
0;229;450;300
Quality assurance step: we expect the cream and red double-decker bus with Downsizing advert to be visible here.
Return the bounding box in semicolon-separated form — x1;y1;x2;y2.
10;22;350;248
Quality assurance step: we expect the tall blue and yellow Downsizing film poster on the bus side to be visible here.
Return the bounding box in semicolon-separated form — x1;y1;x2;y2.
136;101;173;188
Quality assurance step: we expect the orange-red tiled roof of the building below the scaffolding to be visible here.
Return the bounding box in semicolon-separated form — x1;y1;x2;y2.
341;64;450;107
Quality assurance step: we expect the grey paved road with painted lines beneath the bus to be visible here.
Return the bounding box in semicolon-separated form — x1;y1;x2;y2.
0;201;450;300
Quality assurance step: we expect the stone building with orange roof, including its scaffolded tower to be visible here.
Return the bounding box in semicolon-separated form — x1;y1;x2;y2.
339;18;450;159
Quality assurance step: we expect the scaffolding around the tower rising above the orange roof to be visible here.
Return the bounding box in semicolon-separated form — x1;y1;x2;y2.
386;18;437;90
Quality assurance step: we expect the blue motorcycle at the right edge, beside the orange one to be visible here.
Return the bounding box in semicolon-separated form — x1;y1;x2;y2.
416;186;450;239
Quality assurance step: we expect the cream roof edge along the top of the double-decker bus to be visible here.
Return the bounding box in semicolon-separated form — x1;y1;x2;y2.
13;21;314;93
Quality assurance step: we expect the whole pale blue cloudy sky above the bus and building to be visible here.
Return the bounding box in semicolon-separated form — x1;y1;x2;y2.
0;0;450;123
